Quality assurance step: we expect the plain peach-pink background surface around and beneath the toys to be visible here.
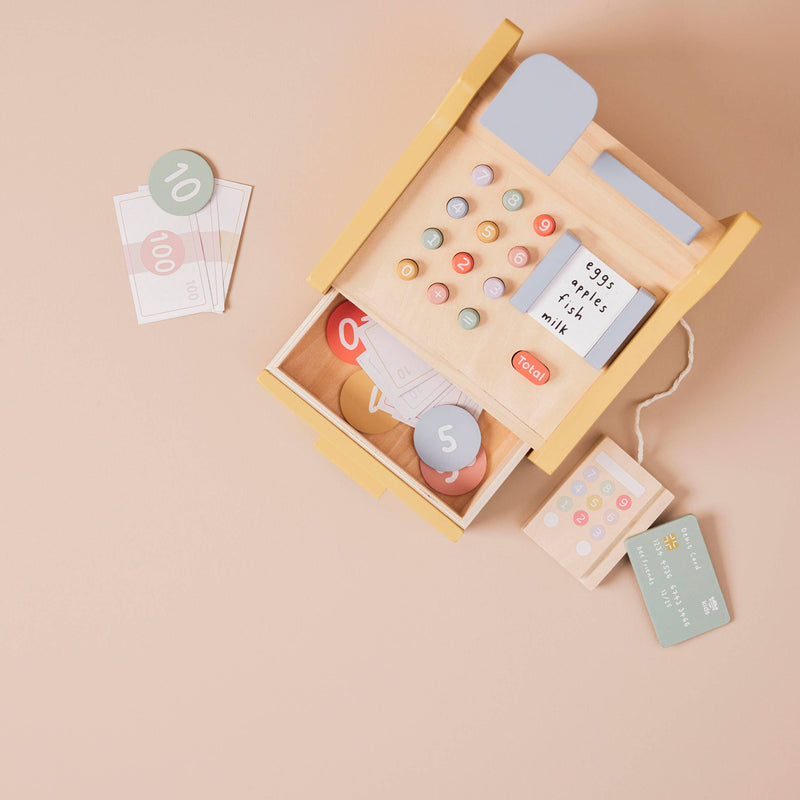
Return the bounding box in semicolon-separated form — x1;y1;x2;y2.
0;0;800;800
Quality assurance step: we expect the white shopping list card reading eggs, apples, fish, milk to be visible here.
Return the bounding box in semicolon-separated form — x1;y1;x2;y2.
528;245;636;356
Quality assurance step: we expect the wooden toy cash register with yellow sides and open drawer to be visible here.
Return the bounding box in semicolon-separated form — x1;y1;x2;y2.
259;20;761;540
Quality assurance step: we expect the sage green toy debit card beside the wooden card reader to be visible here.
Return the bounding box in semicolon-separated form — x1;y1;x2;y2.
625;514;731;647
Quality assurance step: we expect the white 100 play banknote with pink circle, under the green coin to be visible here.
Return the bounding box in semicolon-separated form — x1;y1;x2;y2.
114;192;213;325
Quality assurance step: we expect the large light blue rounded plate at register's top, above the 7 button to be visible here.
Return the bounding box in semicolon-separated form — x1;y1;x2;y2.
480;53;597;175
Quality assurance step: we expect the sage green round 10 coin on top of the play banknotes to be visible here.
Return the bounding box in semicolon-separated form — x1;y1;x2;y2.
148;150;214;217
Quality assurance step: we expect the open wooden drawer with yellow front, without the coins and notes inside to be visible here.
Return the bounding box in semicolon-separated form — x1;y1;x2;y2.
259;290;530;541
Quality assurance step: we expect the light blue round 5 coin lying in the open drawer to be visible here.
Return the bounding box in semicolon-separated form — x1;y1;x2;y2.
414;405;481;472
